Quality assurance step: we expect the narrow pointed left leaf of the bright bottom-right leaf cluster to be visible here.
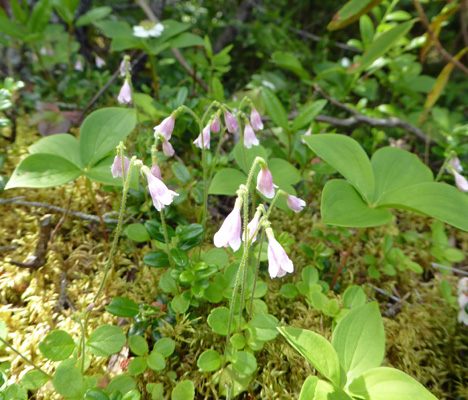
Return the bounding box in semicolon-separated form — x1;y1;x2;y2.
277;327;340;386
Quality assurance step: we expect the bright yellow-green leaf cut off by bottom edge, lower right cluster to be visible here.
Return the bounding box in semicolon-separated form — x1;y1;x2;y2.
349;367;437;400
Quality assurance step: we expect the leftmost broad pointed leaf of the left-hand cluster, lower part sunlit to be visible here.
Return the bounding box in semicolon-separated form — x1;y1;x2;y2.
5;154;83;190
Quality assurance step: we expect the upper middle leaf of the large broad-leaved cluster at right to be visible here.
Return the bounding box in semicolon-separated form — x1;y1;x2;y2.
371;147;434;203
